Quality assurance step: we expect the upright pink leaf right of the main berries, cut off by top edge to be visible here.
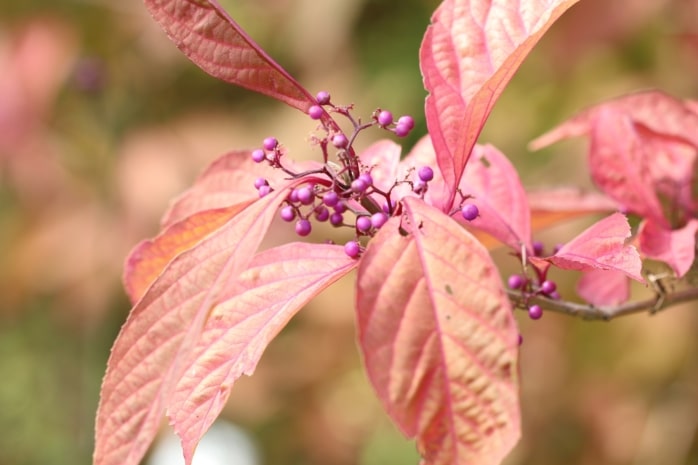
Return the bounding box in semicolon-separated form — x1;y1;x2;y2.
420;0;577;203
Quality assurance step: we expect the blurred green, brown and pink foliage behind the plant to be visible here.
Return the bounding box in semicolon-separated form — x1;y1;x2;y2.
0;0;698;465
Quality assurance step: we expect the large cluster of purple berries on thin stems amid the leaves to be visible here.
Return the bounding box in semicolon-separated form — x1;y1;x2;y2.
247;92;426;258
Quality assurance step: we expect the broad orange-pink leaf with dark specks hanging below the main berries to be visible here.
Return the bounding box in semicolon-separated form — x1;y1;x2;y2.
357;197;520;465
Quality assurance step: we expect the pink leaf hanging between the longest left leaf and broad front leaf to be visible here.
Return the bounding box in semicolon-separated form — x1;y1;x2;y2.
168;243;358;464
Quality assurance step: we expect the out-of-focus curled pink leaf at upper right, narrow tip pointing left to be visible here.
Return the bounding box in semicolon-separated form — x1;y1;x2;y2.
531;91;698;228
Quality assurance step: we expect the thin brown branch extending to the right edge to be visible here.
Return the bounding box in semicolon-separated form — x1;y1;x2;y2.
507;288;698;321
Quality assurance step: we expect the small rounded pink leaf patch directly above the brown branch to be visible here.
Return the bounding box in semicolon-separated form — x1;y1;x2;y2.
577;270;630;307
